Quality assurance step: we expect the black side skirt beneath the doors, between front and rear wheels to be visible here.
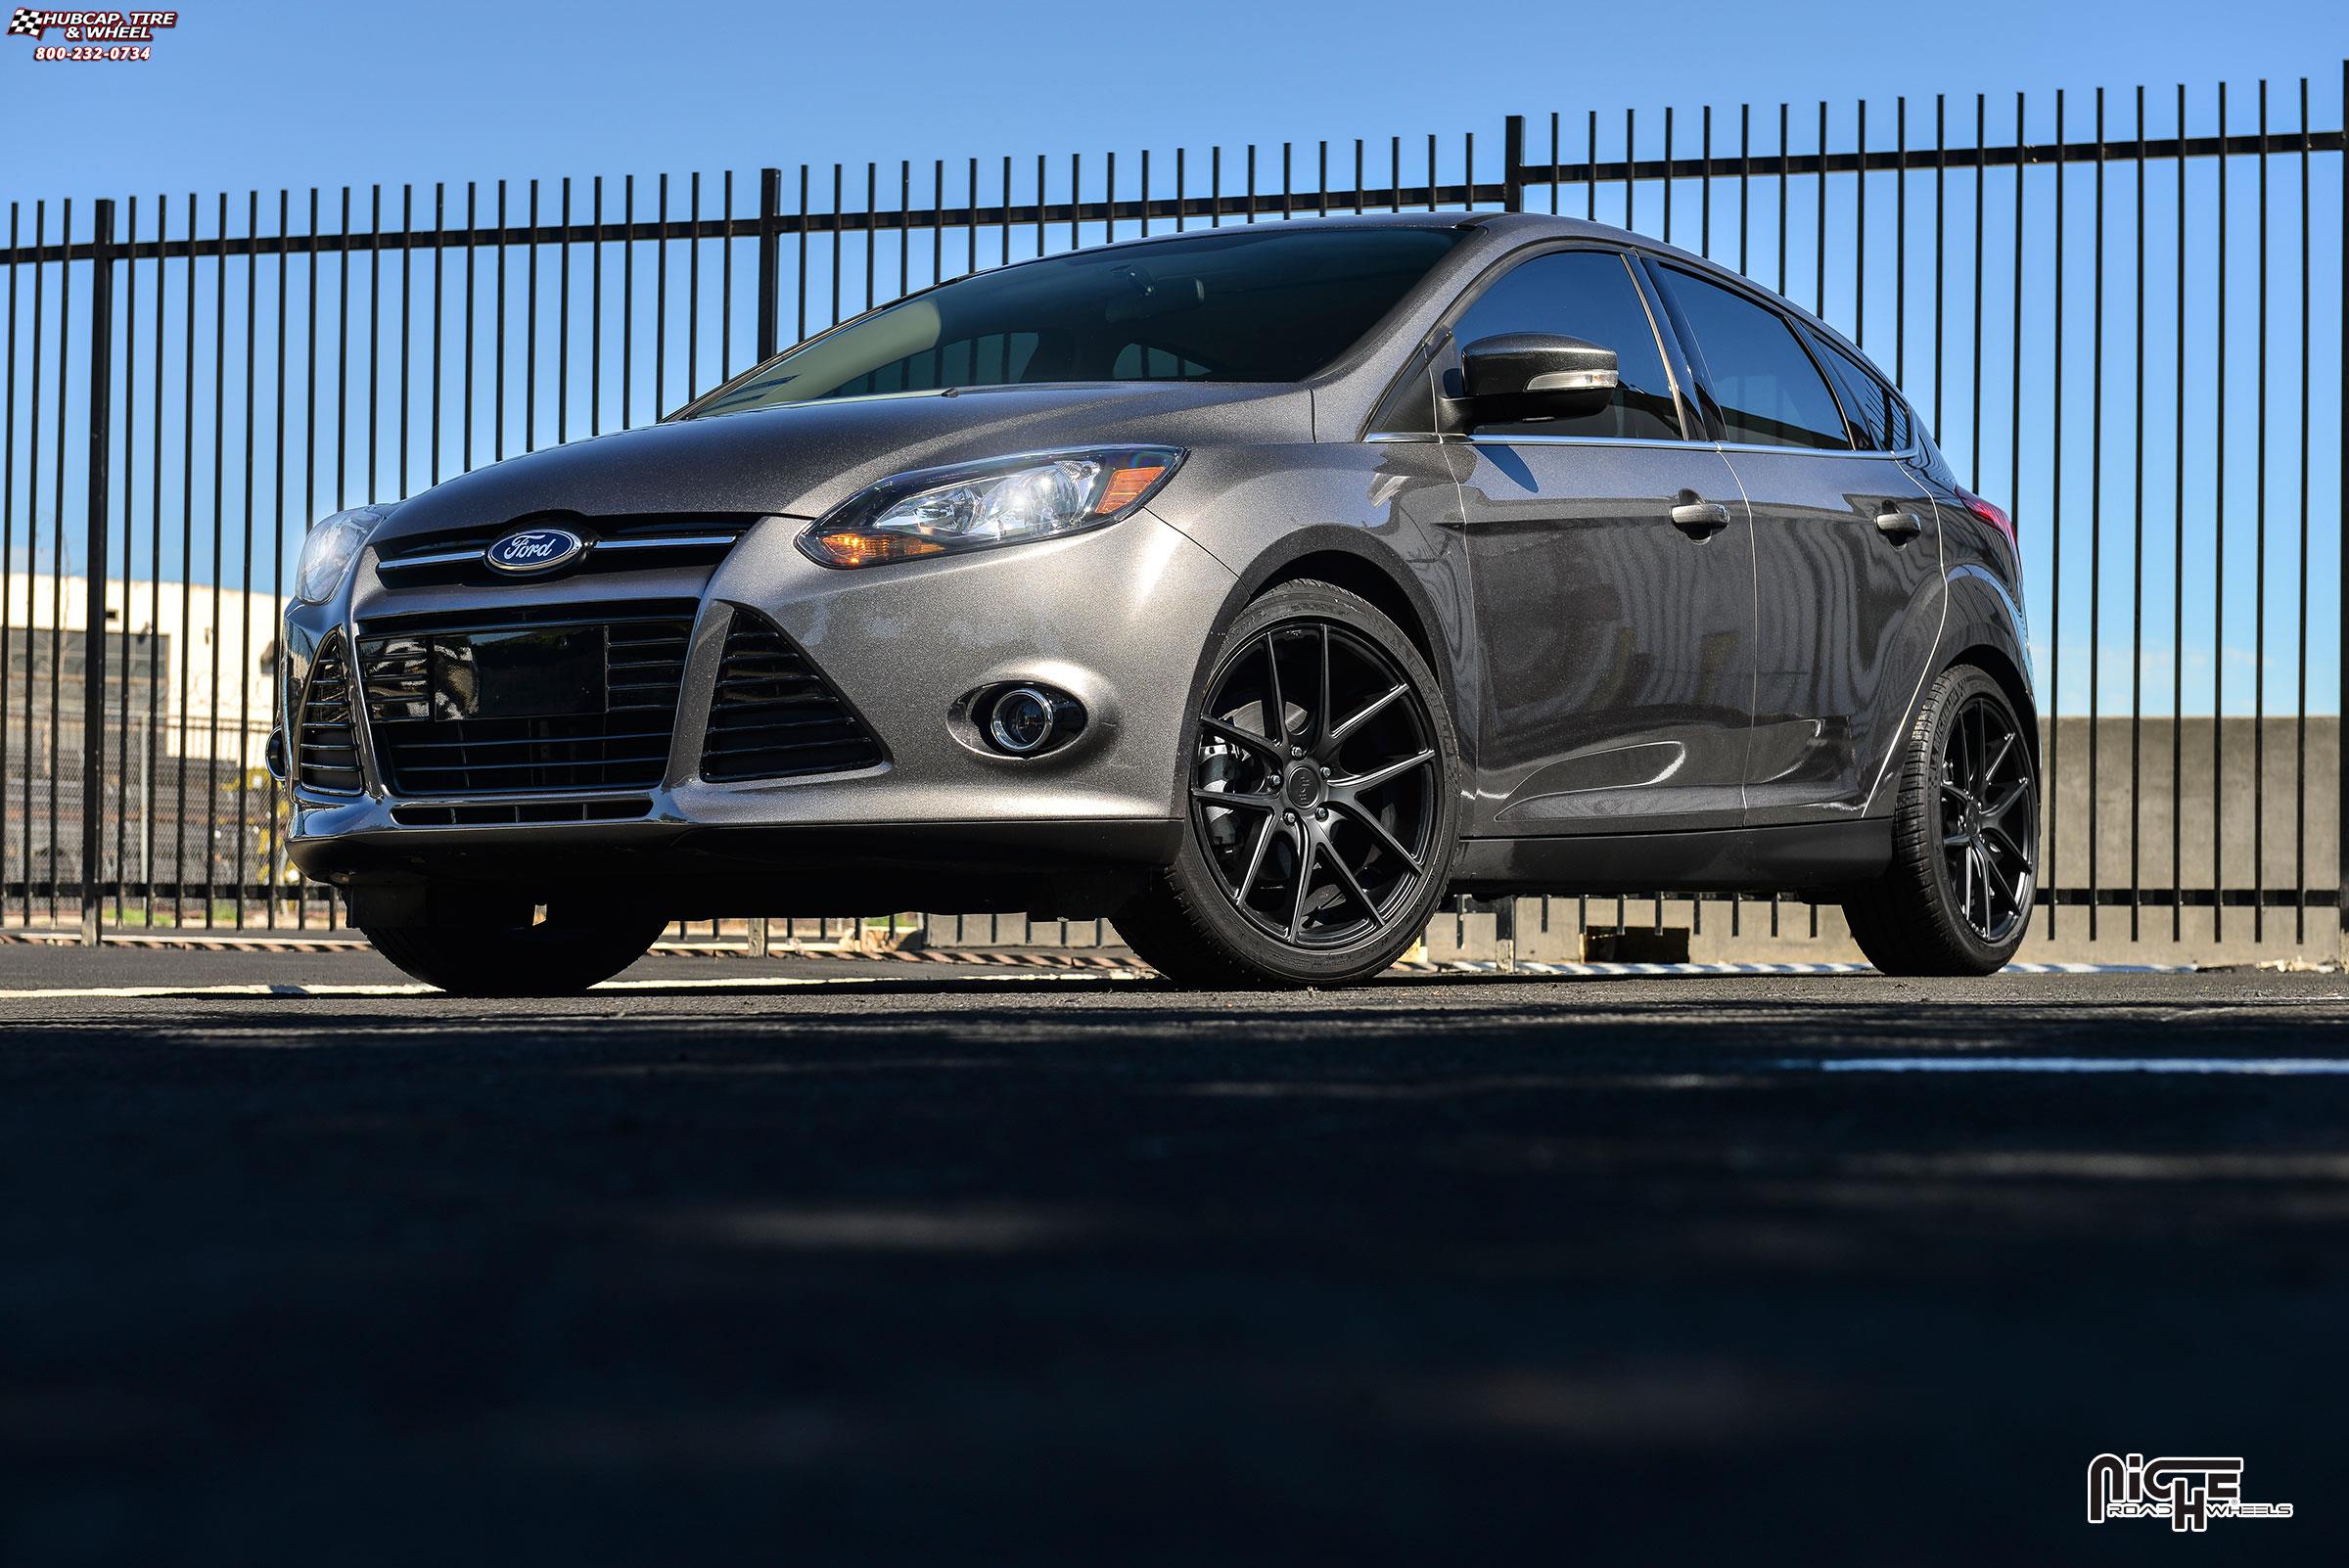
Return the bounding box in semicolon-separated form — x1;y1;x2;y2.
1451;817;1893;897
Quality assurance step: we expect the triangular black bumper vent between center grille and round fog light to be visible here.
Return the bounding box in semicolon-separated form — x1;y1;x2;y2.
703;608;883;782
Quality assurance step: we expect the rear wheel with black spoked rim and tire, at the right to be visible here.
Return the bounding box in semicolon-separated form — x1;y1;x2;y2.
1844;665;2039;974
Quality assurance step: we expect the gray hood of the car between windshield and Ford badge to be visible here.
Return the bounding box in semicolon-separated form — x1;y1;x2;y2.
376;383;1313;540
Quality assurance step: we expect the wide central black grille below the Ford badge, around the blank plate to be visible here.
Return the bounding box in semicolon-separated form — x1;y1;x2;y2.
359;601;695;796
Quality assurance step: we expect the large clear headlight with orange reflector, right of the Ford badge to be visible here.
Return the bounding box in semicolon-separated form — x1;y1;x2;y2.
799;446;1181;566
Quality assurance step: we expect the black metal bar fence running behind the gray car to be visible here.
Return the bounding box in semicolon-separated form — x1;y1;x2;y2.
0;70;2349;939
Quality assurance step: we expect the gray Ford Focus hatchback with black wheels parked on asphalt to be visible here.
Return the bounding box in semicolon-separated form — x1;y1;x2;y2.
272;213;2039;992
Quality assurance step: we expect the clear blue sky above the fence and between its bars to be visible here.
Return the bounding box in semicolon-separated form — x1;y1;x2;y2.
0;0;2349;712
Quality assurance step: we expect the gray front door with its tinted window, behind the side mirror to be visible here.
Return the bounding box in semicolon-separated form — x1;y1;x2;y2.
1438;247;1755;838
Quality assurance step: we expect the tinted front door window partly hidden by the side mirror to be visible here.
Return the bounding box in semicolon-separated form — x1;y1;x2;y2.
1450;252;1680;441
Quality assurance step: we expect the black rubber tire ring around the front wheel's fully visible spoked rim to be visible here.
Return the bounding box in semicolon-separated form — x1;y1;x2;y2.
1170;582;1461;984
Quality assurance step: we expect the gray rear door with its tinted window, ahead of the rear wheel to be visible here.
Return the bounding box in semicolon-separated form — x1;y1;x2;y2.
1651;260;1943;824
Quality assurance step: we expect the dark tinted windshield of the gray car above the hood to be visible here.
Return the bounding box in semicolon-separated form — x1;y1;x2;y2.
688;228;1461;418
